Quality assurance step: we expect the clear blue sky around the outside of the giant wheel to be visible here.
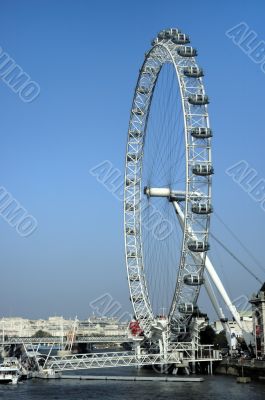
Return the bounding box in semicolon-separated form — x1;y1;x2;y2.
0;0;265;318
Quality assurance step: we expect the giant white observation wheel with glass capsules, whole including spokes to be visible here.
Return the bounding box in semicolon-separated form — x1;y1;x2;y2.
124;29;213;340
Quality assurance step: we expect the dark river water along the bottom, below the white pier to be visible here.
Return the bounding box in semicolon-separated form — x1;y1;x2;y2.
0;368;265;400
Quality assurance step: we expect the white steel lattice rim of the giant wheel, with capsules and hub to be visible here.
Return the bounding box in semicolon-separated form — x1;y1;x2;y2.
124;29;213;340
